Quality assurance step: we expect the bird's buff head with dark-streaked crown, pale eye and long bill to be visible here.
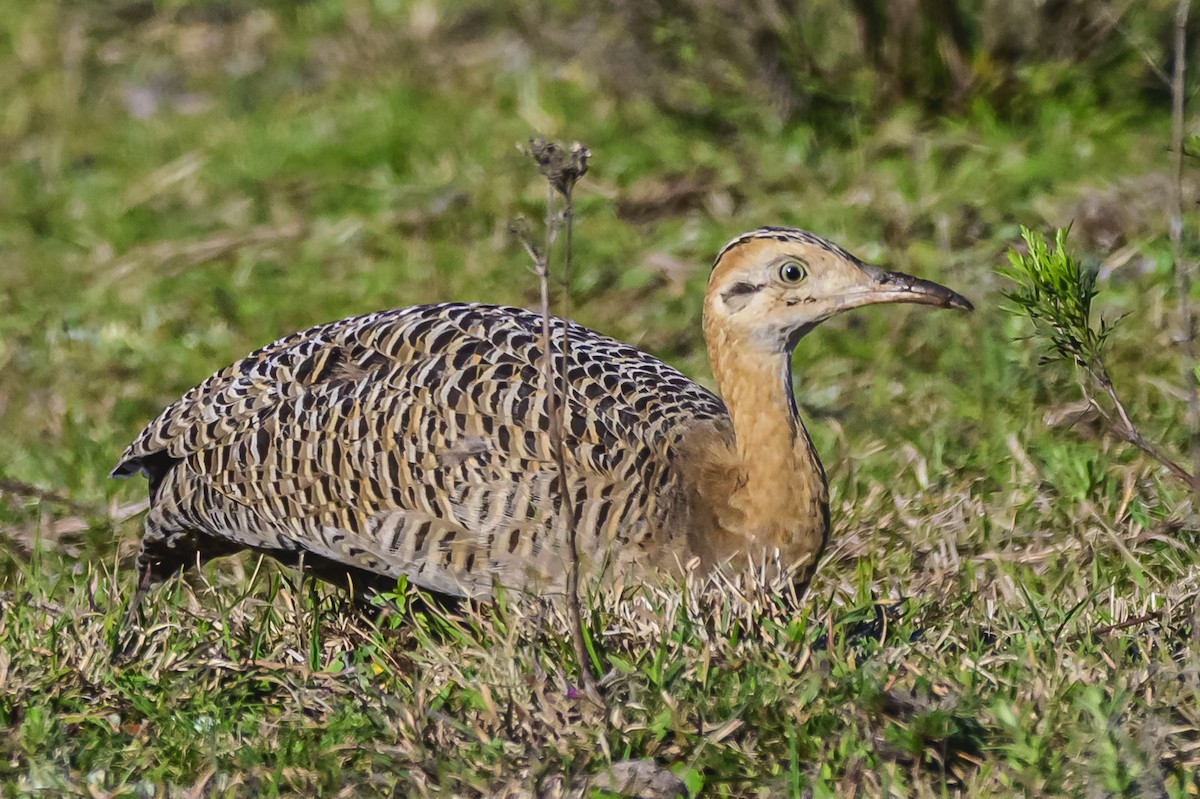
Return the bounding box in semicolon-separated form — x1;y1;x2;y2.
704;228;973;353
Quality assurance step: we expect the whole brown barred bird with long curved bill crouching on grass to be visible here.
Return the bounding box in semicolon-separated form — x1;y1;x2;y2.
112;227;972;601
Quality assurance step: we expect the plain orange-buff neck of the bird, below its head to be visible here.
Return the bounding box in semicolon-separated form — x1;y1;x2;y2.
707;321;828;576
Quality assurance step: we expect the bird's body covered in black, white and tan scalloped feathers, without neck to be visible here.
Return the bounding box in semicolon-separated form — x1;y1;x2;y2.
114;304;726;596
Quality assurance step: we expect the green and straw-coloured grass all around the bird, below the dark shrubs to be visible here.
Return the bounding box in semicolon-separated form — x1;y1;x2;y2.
0;0;1200;797
